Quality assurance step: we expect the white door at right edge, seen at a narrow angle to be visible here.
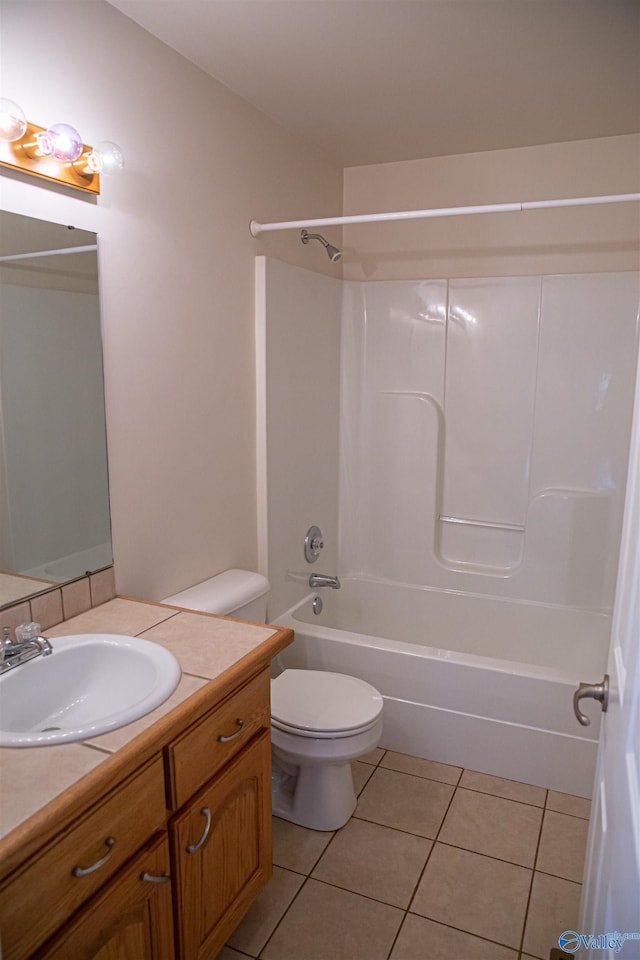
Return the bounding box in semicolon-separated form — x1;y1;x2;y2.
576;342;640;960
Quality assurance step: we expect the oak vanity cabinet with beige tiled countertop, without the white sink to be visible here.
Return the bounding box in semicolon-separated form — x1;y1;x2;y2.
0;598;293;960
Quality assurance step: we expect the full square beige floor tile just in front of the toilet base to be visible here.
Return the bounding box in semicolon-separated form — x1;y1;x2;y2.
312;819;432;909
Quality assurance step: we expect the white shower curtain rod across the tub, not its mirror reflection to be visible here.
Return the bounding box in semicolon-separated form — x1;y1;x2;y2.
249;193;640;237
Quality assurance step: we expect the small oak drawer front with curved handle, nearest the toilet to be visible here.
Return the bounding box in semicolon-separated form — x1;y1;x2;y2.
168;670;271;810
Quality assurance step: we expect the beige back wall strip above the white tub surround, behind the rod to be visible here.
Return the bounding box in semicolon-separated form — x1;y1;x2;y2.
343;134;640;280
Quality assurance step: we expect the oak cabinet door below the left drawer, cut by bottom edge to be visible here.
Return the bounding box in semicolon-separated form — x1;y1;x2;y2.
33;834;175;960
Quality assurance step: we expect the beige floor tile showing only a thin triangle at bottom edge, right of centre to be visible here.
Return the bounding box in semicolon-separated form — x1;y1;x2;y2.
390;913;518;960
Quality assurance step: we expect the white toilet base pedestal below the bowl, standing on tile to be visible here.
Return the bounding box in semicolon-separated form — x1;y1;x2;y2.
272;758;357;830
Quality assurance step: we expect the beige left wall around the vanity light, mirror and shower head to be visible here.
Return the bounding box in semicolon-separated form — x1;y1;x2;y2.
0;0;342;598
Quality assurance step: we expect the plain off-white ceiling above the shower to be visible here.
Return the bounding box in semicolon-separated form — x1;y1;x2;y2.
109;0;640;166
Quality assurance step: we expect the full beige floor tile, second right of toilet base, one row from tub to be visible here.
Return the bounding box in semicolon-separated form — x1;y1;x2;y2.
438;788;542;867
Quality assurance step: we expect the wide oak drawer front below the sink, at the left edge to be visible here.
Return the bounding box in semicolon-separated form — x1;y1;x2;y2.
0;757;167;960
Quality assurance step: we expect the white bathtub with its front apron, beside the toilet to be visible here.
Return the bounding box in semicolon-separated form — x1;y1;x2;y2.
276;578;610;797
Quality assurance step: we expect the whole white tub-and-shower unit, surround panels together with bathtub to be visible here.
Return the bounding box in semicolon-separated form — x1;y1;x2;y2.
256;259;640;796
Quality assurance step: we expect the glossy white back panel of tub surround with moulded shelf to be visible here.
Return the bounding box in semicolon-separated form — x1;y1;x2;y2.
339;273;640;610
